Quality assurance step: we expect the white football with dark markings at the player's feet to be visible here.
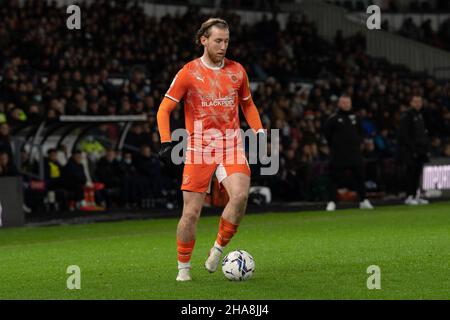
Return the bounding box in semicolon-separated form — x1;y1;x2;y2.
222;250;255;281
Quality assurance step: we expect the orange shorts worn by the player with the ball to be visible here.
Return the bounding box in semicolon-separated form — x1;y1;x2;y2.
181;152;250;193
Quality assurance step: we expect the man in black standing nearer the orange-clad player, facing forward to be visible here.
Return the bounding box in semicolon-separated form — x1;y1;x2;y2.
324;95;373;211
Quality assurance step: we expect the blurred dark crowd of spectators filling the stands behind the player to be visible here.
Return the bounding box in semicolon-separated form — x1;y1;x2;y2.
0;0;450;210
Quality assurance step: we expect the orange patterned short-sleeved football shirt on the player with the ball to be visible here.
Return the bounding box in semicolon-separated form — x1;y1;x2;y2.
165;58;251;152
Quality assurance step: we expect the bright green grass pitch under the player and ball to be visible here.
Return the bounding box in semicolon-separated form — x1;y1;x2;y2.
0;203;450;300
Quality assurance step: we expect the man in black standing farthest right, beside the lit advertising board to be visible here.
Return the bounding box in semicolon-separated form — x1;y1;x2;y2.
397;95;429;205
